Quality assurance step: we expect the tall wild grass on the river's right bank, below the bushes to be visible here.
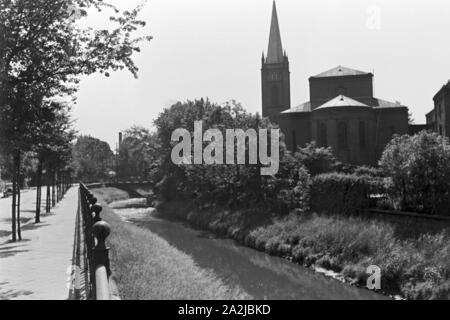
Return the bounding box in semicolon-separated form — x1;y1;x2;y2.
247;215;450;299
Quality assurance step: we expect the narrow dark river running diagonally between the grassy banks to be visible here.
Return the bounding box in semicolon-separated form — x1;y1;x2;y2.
113;200;387;300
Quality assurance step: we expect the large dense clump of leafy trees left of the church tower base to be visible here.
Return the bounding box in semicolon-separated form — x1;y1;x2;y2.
155;99;299;209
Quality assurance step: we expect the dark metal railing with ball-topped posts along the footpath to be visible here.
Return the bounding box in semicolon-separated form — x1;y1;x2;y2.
79;183;111;300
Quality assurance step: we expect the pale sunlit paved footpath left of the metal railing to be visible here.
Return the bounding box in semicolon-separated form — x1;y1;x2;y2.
0;187;78;300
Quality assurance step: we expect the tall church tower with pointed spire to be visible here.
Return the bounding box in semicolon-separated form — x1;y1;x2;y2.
261;1;291;122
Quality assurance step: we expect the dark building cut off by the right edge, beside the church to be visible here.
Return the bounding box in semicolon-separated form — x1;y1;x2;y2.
427;80;450;138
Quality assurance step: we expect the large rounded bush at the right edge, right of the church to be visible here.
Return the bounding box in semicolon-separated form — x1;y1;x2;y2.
380;131;450;215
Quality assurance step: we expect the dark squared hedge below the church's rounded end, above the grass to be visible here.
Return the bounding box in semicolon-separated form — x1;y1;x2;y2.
310;173;383;215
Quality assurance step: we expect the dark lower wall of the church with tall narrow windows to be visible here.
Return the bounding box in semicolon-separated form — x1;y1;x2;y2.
279;107;409;166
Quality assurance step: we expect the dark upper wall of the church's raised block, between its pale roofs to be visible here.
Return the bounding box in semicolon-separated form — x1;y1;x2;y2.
309;74;373;109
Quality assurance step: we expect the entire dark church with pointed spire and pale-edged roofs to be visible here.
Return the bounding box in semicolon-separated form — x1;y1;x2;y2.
261;2;413;165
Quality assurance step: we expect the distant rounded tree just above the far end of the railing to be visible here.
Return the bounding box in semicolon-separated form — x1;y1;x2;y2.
72;136;114;182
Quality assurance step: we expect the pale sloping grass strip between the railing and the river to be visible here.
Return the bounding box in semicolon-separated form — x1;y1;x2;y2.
94;188;250;300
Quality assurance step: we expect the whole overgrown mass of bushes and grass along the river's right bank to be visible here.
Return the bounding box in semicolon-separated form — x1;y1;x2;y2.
105;100;450;299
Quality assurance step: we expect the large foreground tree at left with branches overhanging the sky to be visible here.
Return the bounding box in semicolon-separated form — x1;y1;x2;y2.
0;0;151;241
